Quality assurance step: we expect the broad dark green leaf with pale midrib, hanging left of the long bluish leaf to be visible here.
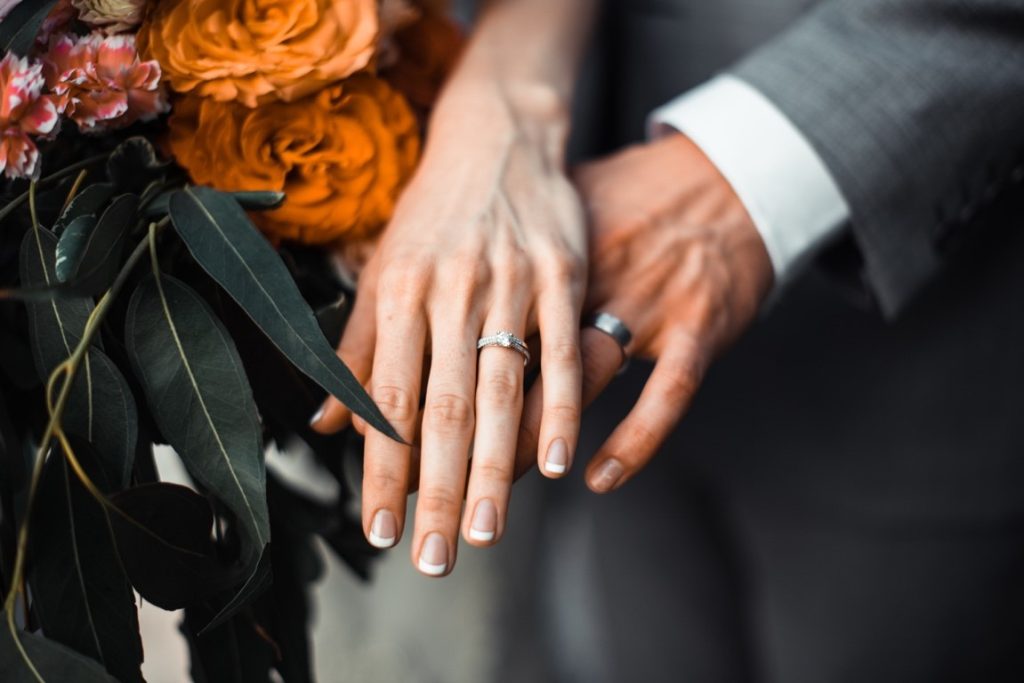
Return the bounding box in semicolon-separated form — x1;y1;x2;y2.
125;275;270;566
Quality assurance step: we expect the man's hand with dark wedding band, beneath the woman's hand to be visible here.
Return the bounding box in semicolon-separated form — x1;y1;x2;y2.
518;134;773;493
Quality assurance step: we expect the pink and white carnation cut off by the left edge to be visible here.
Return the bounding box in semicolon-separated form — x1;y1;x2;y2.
0;54;60;178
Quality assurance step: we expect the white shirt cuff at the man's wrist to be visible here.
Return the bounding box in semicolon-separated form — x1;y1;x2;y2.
650;75;850;285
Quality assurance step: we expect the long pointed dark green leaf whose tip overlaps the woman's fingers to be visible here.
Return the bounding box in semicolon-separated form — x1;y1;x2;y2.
170;187;401;440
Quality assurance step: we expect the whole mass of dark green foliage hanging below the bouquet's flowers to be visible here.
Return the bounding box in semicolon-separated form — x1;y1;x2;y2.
0;136;385;683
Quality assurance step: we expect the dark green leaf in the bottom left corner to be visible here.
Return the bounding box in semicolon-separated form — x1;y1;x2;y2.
0;621;118;683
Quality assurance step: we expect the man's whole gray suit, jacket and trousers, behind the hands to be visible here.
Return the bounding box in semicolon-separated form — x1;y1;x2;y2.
542;0;1024;683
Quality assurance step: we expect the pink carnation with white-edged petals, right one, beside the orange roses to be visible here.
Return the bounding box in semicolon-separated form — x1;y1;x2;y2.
43;33;169;132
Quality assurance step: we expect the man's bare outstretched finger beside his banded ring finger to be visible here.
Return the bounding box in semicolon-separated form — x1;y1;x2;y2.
586;333;706;494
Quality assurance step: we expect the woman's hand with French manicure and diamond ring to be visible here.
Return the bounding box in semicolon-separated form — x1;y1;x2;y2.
313;72;586;575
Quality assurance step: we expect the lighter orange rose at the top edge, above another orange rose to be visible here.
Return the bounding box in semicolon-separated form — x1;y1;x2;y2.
138;0;378;106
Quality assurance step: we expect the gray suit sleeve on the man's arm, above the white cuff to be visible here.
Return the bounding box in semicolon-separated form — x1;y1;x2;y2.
732;0;1024;315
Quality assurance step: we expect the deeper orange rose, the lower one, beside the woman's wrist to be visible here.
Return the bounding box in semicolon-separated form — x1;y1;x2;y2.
168;73;420;245
